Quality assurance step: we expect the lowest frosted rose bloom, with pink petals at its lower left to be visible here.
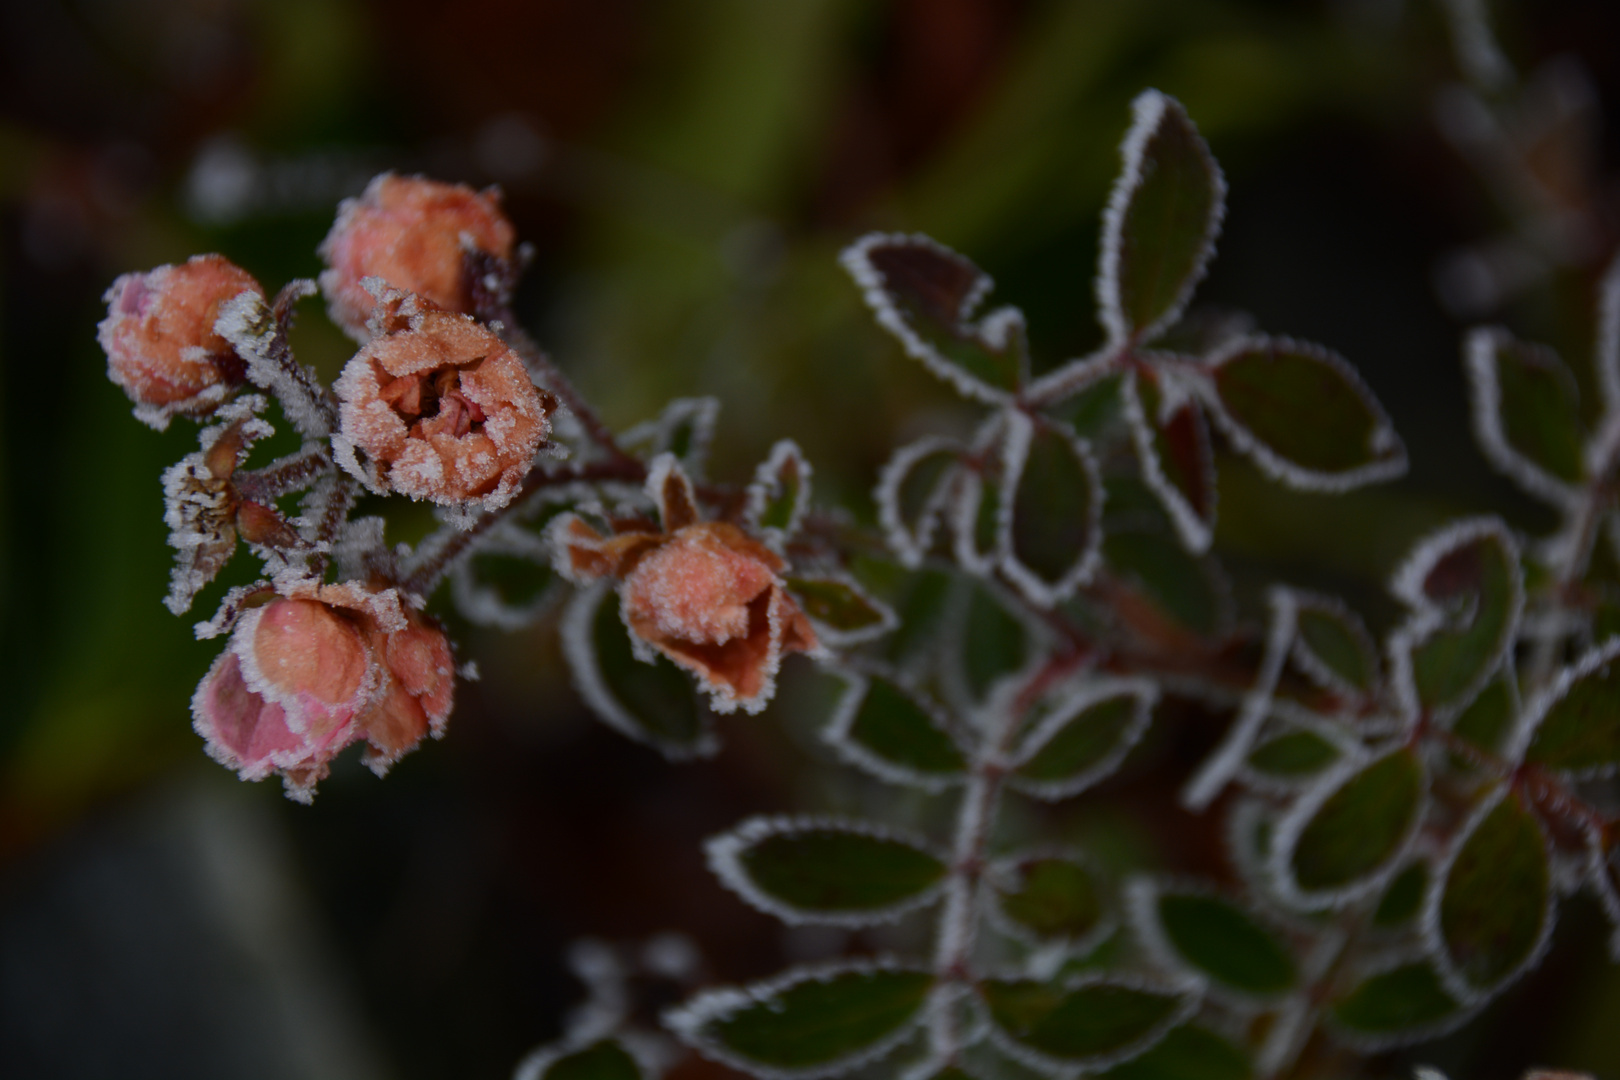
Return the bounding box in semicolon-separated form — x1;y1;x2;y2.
191;581;455;801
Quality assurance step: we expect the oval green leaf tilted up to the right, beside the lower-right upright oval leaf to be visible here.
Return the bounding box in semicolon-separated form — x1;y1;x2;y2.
1273;748;1427;907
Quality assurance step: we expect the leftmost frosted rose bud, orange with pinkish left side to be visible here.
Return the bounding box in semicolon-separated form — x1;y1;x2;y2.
97;254;264;429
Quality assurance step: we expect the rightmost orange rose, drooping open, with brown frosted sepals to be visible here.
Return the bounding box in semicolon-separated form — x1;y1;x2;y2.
552;453;821;712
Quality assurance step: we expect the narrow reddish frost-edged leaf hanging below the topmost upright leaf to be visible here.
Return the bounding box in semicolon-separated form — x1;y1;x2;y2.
1121;374;1217;555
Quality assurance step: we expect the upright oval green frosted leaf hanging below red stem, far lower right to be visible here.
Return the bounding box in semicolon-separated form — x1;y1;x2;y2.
1439;789;1552;993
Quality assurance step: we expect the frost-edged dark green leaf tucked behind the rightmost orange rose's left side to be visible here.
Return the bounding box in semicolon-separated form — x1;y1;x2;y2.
561;581;719;761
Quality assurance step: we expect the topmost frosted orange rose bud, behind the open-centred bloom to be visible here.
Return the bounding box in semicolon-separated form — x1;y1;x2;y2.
319;173;515;342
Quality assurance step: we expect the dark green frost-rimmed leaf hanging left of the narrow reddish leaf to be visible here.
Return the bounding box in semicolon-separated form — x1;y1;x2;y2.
998;413;1103;607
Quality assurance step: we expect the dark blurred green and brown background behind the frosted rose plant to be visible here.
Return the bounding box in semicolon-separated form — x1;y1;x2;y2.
0;0;1620;1078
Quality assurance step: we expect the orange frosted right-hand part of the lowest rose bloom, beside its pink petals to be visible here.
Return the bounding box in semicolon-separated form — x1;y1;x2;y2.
360;612;455;776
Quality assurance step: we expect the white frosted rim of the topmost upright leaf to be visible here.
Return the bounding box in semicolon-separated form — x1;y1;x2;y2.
1097;89;1226;351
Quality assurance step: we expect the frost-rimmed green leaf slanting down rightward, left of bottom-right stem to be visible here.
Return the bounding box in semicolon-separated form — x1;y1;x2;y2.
1124;876;1301;1006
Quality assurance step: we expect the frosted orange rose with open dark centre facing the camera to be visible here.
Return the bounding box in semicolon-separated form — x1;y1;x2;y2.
334;295;556;508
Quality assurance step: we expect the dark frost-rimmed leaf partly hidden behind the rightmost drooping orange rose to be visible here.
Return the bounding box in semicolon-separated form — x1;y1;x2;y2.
562;581;716;759
